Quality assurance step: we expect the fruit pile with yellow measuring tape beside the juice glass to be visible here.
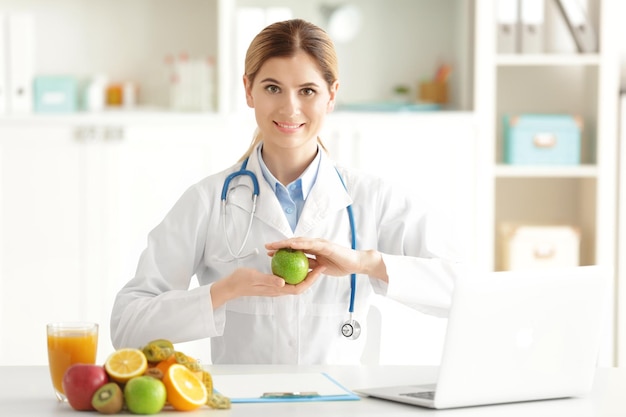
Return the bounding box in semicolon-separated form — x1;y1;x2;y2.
63;339;230;414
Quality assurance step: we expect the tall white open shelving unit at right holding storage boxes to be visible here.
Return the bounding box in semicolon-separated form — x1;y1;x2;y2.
474;0;619;365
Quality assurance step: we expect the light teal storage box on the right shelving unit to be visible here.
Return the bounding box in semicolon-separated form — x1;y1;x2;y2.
504;114;582;165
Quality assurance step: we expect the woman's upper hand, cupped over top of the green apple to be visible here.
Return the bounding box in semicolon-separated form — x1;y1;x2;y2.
265;237;387;281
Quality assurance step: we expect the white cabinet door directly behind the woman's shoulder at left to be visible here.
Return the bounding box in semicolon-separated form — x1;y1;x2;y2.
104;123;229;363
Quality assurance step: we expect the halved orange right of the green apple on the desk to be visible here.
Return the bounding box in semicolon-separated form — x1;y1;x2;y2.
163;363;208;411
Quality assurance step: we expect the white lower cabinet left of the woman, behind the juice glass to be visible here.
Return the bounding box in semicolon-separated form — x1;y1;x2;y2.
0;116;252;365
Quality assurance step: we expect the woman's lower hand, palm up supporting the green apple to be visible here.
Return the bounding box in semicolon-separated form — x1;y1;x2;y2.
211;265;325;309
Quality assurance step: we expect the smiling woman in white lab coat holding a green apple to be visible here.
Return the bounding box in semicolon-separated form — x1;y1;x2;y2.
111;19;456;364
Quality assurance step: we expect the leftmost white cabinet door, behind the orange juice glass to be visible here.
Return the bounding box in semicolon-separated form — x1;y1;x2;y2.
0;126;85;365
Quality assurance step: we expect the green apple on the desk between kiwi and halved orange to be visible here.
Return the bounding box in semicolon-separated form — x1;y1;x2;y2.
124;375;167;414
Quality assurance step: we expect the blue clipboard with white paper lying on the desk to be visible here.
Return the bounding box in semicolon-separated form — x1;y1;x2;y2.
212;372;360;403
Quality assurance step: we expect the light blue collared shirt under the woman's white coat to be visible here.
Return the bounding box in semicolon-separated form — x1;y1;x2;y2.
257;146;321;231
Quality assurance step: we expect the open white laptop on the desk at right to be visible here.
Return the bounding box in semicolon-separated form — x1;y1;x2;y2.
354;266;609;409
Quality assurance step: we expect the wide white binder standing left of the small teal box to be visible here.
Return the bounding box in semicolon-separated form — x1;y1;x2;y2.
7;13;35;114
